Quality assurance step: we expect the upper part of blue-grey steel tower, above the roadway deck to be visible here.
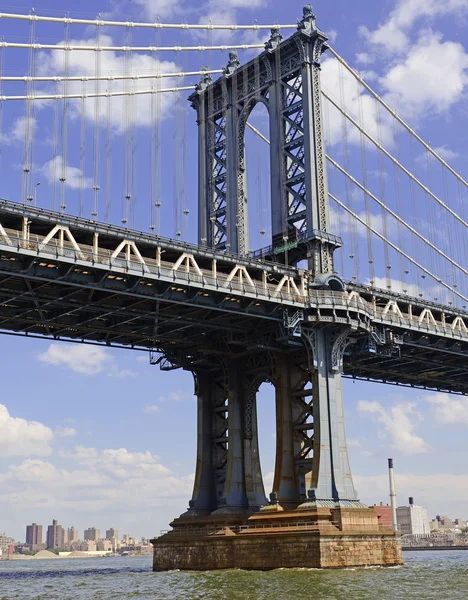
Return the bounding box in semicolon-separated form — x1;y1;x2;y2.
190;7;339;273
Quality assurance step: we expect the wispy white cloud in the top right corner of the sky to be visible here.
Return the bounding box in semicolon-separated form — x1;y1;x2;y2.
360;0;468;53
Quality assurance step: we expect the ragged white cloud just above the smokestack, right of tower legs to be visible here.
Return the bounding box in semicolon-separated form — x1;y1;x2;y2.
358;400;431;454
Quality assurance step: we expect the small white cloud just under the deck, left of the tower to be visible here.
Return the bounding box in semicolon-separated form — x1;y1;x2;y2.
38;343;112;375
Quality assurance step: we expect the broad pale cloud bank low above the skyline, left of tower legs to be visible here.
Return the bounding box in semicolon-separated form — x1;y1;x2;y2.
0;446;193;517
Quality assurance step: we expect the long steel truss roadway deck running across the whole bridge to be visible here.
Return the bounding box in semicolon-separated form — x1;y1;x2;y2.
0;201;468;393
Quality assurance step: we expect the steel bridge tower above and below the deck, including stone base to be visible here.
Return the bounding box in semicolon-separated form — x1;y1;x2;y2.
154;5;401;569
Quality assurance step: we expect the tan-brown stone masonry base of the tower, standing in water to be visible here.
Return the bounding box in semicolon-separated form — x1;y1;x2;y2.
152;510;403;571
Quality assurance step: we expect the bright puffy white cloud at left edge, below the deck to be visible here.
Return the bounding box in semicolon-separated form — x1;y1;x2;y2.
0;404;54;456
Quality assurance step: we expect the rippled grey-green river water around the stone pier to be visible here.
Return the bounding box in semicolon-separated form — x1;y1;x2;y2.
0;551;468;600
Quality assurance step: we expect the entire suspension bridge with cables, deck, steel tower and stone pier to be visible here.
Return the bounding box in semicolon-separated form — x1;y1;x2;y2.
0;5;468;569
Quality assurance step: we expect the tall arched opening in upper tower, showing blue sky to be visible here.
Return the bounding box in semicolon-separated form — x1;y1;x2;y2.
244;101;272;251
